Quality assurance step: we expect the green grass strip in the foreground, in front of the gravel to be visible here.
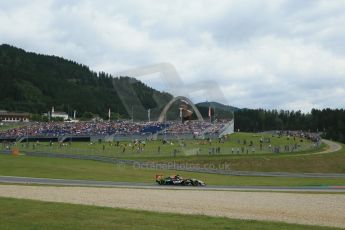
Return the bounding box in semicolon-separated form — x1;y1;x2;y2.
0;198;336;230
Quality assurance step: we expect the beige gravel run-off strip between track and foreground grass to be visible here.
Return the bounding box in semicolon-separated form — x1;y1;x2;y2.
0;185;345;227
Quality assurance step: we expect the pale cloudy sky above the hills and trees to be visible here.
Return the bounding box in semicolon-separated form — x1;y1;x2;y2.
0;0;345;112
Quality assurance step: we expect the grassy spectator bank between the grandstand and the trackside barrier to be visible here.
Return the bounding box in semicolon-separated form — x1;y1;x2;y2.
2;133;345;173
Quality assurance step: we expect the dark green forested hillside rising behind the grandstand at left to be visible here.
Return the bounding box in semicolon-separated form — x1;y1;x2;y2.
0;45;172;119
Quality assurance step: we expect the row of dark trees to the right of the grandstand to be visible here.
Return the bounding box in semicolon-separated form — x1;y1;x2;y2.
235;109;345;143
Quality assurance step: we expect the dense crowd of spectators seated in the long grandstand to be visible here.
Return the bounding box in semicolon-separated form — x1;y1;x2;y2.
0;121;226;138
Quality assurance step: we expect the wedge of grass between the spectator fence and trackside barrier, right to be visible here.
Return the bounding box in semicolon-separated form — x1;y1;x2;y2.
147;145;345;173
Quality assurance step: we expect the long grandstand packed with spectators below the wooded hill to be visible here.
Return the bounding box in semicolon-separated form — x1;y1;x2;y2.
0;121;231;142
